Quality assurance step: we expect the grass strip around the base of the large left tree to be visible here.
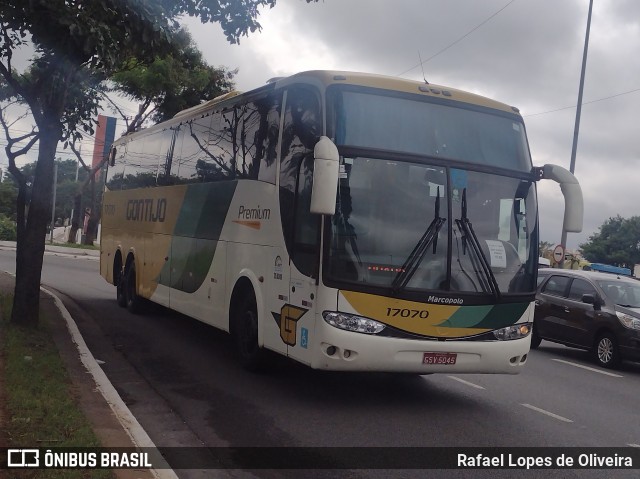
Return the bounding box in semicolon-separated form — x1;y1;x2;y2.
0;294;114;479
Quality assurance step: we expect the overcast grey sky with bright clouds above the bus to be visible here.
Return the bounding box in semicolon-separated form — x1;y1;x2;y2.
179;0;640;253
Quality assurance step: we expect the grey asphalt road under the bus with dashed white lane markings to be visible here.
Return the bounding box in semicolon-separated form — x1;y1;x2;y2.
0;251;640;478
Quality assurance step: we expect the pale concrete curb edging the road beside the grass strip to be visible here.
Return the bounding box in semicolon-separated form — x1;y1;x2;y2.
40;286;178;479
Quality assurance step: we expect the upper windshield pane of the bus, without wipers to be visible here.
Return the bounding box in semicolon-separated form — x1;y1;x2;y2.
329;86;531;173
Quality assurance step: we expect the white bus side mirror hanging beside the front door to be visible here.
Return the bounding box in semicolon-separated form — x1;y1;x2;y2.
310;136;340;215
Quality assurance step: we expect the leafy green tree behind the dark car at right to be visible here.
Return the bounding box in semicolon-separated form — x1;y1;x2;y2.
580;215;640;269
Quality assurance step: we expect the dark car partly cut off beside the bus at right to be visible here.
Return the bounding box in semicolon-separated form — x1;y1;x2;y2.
531;269;640;368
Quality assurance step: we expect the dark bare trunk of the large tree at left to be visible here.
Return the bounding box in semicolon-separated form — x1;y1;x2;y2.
11;121;60;327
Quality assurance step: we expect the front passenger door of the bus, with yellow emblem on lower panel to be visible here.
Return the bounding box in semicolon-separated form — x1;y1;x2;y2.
287;155;321;364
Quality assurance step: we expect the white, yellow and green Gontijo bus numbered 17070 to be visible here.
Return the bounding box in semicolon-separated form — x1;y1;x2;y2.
100;71;582;374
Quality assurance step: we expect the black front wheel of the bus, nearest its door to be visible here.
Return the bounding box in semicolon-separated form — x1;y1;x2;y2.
233;294;265;371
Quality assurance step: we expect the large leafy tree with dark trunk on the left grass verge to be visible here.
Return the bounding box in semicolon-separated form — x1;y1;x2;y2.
0;0;296;326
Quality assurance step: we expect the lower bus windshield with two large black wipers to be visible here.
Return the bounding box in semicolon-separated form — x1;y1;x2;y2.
325;156;537;299
